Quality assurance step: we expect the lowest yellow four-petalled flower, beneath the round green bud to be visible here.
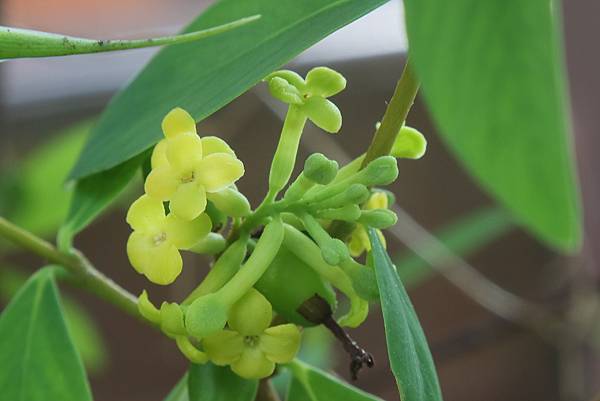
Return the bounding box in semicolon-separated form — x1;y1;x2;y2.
202;289;300;379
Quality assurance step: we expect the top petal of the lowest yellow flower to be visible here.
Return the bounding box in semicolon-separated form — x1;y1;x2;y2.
227;288;273;336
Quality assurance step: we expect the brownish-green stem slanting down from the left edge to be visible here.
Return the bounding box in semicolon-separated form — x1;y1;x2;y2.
0;217;143;319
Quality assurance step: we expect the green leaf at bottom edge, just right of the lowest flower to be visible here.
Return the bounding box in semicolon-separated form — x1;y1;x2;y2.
286;360;380;401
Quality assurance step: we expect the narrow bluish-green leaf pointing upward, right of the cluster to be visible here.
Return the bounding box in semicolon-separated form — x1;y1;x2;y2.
369;228;442;401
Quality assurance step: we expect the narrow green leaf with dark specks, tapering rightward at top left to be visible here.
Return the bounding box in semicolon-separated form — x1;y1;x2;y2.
0;16;259;59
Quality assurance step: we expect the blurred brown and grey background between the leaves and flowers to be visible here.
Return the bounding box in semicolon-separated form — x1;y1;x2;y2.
0;0;600;401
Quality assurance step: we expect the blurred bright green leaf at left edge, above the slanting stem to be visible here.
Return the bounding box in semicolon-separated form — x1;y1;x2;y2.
0;121;92;236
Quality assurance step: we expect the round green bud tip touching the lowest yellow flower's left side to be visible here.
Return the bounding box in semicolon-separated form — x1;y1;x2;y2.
185;293;229;338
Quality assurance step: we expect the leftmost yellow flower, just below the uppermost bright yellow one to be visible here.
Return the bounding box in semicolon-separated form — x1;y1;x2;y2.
127;195;212;285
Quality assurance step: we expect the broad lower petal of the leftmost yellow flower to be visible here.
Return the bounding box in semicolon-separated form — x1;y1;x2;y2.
127;231;183;285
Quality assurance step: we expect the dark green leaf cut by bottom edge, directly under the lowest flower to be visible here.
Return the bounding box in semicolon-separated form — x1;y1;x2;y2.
188;363;258;401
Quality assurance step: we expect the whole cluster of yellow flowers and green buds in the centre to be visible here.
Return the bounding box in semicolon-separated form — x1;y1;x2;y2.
127;67;426;379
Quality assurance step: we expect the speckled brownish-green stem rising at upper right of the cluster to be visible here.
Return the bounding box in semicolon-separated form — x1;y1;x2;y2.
361;60;420;168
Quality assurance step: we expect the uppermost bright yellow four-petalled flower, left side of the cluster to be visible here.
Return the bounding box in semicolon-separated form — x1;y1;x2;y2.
145;108;244;220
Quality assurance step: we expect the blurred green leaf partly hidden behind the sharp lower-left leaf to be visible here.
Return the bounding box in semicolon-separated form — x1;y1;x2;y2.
0;266;108;373
